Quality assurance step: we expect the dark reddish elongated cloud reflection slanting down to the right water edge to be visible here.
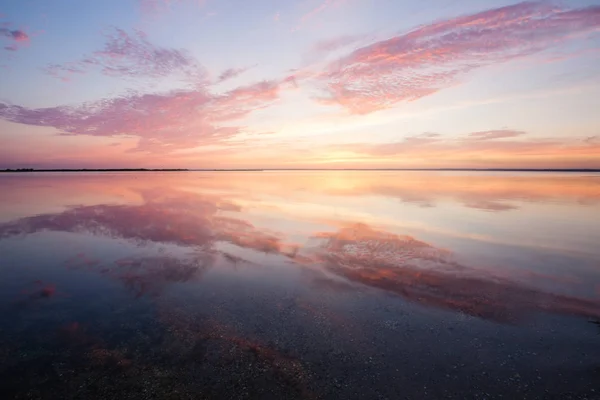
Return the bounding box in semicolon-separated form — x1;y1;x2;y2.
300;224;600;322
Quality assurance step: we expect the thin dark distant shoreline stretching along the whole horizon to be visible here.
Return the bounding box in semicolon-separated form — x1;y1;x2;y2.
0;168;600;173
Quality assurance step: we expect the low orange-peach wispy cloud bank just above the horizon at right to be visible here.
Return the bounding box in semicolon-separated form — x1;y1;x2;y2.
331;129;600;168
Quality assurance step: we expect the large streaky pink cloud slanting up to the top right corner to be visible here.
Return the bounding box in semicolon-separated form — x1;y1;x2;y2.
319;2;600;114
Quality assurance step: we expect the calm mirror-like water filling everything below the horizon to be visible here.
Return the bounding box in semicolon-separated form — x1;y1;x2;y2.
0;172;600;399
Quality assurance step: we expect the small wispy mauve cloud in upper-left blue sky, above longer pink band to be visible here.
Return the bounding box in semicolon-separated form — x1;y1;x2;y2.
46;28;207;85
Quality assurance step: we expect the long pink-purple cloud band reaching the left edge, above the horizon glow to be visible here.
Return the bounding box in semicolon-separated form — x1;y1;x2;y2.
0;77;284;153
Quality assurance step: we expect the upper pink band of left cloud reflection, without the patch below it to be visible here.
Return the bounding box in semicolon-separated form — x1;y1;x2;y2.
0;191;280;251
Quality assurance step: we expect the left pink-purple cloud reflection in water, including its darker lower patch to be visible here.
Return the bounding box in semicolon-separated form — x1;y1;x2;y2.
0;184;294;297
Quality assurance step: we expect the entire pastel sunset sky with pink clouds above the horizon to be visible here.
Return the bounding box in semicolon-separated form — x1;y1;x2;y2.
0;0;600;168
